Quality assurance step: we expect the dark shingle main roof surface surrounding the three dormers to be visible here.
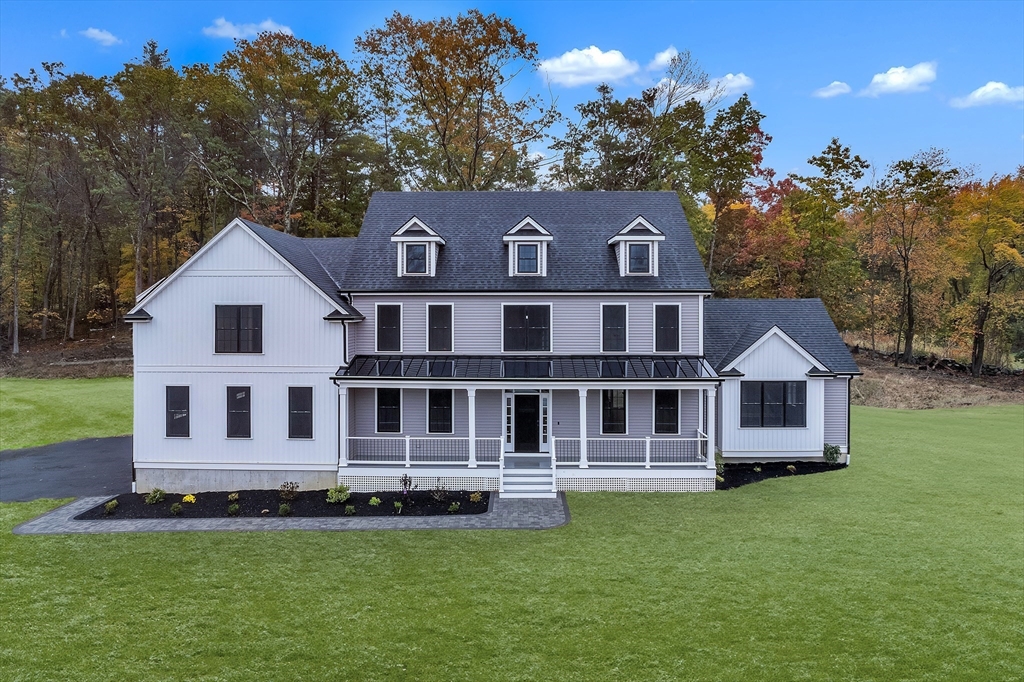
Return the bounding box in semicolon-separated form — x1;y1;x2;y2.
344;191;711;292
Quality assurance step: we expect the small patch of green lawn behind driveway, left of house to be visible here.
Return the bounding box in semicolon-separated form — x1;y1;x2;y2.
0;377;132;450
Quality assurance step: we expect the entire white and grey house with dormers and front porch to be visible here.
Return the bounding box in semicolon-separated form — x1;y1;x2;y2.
127;188;858;497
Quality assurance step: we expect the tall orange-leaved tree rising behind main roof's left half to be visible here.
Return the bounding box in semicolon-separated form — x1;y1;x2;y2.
355;9;557;189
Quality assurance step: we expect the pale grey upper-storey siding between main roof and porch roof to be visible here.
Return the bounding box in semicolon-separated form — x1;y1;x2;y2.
349;294;703;356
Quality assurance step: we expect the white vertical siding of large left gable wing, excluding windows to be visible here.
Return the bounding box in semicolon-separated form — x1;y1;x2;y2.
134;226;344;485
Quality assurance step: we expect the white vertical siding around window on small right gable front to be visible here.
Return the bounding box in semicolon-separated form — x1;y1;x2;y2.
718;335;831;460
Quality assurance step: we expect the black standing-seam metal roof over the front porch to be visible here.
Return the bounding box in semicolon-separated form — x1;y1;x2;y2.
335;355;709;381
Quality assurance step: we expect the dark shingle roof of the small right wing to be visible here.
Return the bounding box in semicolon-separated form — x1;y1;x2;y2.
705;298;860;374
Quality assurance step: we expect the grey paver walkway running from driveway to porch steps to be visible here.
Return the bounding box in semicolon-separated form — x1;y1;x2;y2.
14;493;569;536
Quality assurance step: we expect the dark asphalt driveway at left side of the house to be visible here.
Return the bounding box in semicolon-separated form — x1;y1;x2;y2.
0;436;131;502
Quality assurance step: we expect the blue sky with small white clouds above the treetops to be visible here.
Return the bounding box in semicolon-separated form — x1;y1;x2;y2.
0;0;1024;177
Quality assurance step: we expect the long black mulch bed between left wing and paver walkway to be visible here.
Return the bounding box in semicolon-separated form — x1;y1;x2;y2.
75;491;490;520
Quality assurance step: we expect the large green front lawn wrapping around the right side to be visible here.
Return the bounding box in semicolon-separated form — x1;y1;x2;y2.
0;406;1024;682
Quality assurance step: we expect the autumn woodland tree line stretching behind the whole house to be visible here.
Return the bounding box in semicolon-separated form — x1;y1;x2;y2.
0;10;1024;373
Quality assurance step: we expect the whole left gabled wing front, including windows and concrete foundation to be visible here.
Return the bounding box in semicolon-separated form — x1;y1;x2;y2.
134;221;345;493
